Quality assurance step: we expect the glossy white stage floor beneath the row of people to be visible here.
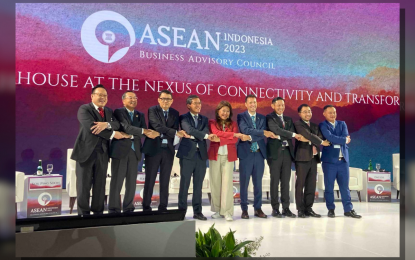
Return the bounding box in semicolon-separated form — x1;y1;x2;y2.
18;190;400;257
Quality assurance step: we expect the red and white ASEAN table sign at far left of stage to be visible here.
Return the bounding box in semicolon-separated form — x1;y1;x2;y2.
21;174;62;218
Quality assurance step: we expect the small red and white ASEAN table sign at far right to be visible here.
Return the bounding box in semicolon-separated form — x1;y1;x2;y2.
367;172;391;202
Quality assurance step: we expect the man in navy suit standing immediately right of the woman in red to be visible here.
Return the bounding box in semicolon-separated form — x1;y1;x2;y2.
237;95;276;219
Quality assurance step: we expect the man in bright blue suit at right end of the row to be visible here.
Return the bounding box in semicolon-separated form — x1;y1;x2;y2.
319;105;362;218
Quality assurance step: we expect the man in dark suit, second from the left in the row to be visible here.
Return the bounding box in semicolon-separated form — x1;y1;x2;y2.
108;91;160;213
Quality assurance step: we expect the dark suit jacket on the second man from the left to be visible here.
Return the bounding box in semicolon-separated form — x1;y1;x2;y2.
110;107;146;161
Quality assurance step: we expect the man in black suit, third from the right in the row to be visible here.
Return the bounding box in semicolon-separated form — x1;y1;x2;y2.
267;97;302;218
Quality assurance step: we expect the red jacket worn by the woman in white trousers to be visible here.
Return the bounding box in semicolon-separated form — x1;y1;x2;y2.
208;119;239;162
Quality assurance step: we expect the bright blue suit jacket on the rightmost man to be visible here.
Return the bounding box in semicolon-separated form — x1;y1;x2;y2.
319;120;349;163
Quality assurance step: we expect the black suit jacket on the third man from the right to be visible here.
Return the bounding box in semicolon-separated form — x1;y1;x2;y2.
267;112;295;160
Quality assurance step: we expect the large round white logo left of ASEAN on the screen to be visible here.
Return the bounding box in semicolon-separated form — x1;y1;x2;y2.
81;11;135;63
